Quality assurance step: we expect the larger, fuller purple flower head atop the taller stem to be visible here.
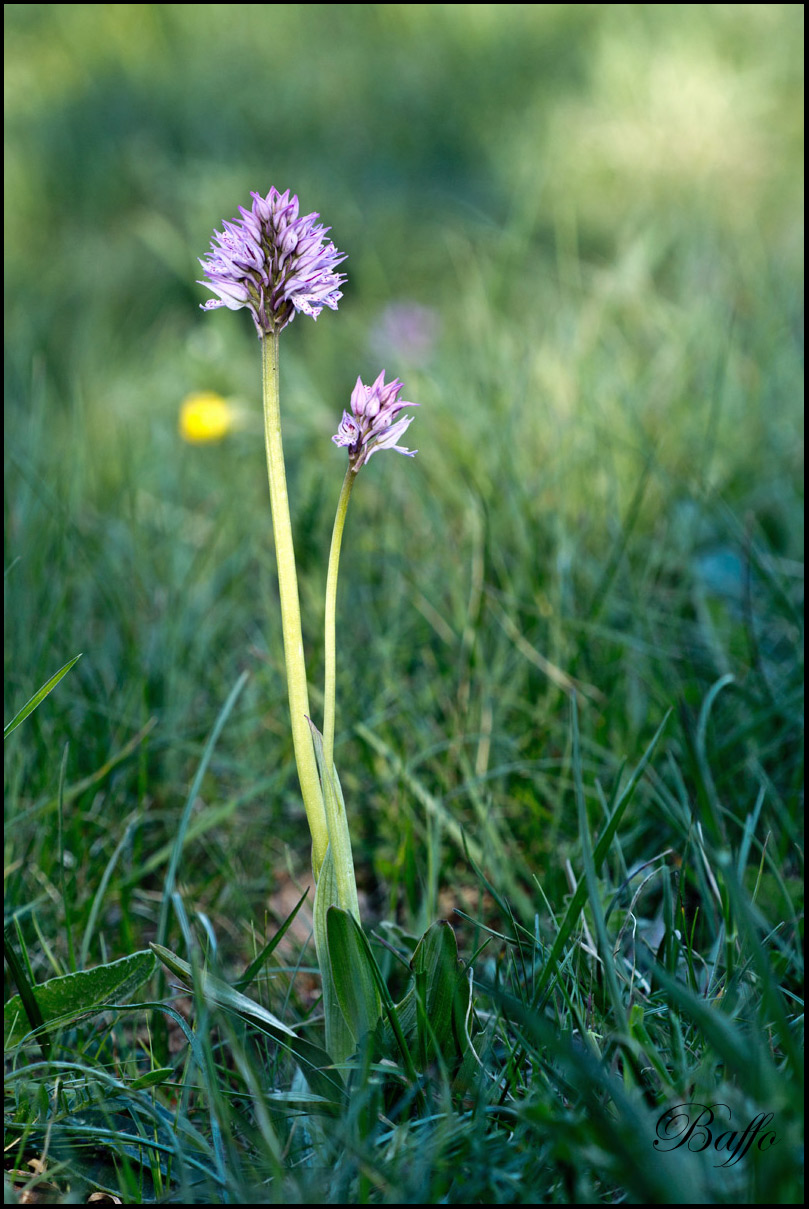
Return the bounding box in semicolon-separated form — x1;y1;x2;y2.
198;189;346;339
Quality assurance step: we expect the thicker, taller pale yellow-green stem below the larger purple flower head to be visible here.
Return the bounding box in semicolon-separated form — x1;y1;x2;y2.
261;332;330;880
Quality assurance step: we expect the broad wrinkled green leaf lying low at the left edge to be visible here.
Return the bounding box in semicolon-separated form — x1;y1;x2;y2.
4;949;155;1049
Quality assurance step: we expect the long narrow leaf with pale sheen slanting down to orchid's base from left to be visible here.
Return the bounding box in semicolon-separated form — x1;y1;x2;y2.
151;944;345;1109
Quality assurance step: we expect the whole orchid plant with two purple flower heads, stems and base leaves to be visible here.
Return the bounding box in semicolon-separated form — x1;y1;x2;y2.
155;189;469;1082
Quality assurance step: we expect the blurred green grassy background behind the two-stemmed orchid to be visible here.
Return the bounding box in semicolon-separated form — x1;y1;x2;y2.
5;4;803;958
